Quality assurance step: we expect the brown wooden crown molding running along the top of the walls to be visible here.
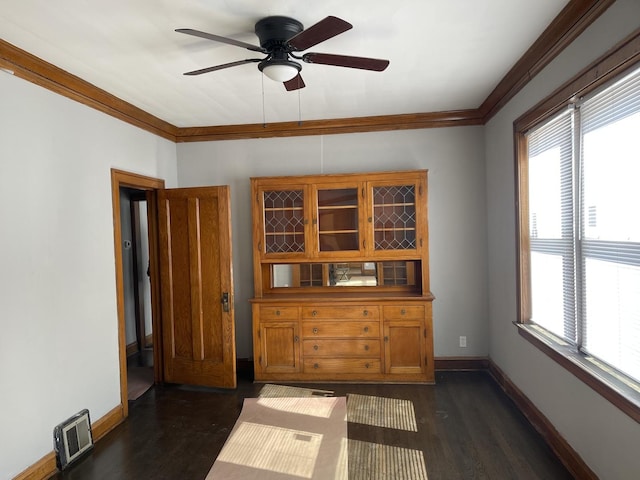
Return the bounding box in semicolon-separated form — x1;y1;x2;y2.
0;0;614;143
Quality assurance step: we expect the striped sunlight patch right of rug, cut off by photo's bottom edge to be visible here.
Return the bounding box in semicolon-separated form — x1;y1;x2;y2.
348;439;427;480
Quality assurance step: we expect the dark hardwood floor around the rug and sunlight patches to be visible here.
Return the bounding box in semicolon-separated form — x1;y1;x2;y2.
53;372;572;480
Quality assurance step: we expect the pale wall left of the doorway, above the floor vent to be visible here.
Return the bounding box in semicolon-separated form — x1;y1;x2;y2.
0;72;177;479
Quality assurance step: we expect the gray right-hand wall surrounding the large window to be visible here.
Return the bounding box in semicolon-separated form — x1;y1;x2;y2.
485;0;640;480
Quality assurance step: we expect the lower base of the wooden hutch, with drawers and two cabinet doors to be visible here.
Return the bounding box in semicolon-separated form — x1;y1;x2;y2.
252;295;434;383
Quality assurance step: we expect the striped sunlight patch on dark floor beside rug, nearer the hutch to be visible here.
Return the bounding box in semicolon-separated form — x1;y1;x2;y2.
347;394;418;432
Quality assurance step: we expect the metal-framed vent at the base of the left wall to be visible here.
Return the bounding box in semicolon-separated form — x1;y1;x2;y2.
53;409;93;470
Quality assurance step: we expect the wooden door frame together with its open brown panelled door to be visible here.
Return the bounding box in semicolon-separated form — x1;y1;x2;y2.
111;169;236;419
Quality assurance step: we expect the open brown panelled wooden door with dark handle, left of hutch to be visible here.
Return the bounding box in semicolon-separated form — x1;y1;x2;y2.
158;186;236;388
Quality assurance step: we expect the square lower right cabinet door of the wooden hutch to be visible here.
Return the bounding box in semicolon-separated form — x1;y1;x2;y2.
384;320;426;374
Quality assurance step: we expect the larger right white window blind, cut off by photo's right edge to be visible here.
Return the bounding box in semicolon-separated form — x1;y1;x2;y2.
580;66;640;381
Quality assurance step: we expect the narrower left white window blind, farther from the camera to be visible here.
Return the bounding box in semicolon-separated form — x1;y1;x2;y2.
528;109;577;343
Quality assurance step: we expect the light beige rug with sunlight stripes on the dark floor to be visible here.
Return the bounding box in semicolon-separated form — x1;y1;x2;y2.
206;396;348;480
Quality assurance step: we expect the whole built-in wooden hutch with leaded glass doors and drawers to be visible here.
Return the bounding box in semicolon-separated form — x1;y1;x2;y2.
251;170;434;383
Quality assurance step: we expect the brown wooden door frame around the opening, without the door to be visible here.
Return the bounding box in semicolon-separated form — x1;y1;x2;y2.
111;168;165;419
